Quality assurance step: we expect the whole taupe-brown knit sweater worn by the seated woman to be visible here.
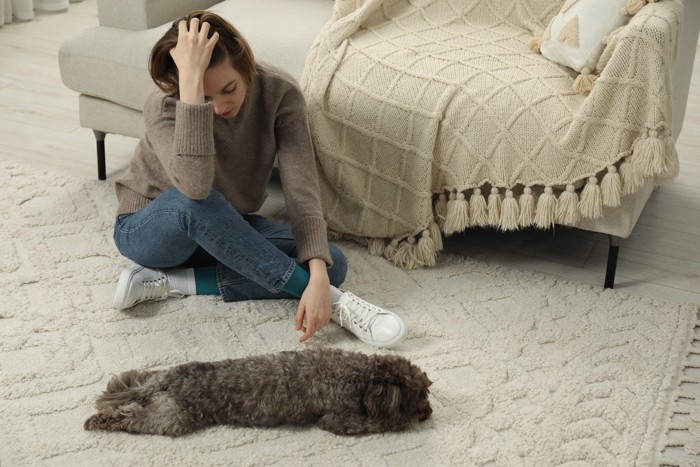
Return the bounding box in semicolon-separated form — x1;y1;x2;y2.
116;63;332;264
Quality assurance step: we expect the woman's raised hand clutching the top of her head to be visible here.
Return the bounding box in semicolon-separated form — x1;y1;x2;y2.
170;18;219;104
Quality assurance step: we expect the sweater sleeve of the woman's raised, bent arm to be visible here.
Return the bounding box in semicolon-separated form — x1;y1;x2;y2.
144;92;215;199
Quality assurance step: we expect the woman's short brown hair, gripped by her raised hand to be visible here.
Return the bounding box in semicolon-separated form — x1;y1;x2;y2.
148;10;256;96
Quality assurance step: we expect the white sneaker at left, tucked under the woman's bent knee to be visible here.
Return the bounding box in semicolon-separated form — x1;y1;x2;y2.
113;264;185;310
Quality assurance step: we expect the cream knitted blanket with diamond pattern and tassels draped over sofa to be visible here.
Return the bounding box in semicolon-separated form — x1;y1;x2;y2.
302;0;682;267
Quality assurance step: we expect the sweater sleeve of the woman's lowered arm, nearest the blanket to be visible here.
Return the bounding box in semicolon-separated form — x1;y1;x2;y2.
275;86;332;265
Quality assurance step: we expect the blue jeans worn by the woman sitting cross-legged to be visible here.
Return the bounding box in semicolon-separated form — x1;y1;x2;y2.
114;188;347;302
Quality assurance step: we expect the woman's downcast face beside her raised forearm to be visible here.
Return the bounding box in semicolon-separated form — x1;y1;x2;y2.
204;60;246;118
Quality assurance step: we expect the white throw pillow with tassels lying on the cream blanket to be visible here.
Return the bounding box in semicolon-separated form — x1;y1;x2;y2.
540;0;631;73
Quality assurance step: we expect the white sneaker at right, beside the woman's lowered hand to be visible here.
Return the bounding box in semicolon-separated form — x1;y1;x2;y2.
331;292;406;347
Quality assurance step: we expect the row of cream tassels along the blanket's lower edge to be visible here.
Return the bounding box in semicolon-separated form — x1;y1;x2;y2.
352;123;678;269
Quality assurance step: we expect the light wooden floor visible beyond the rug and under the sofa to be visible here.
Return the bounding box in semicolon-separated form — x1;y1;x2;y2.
0;0;700;304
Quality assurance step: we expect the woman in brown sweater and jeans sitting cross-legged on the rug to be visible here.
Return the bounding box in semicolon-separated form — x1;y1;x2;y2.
108;11;406;347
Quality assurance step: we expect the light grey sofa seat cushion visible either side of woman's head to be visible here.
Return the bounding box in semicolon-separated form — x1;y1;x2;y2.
59;0;333;110
